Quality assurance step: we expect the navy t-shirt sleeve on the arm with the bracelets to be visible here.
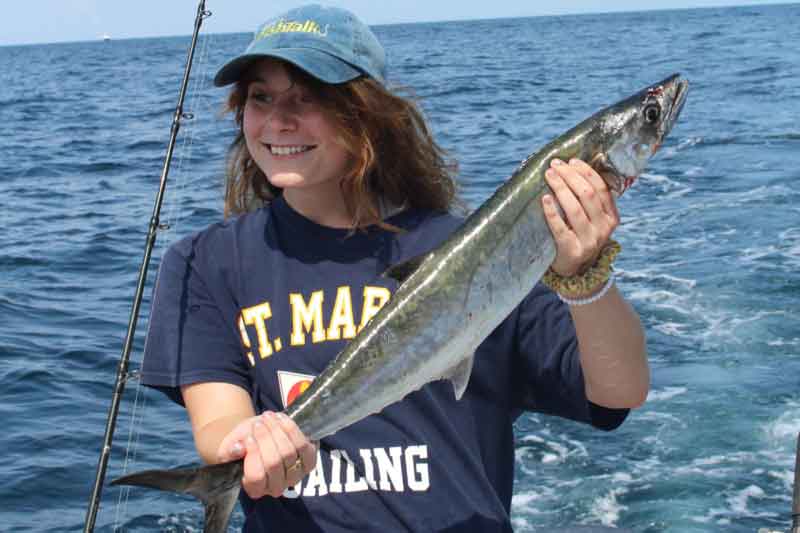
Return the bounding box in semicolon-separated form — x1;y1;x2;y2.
514;283;629;430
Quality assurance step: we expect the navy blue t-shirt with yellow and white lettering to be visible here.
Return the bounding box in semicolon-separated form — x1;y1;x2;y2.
142;198;627;533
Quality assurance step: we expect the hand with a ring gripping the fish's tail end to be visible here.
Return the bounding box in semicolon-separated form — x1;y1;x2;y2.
217;411;317;500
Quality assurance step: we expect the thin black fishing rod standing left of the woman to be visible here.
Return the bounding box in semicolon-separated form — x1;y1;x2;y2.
83;0;211;533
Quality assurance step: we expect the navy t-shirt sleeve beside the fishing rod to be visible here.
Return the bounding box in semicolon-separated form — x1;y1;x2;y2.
142;236;252;405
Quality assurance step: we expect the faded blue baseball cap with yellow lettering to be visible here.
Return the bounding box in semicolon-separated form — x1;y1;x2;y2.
214;5;386;87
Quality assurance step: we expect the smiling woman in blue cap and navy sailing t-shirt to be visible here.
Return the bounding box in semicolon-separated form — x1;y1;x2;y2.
142;6;649;531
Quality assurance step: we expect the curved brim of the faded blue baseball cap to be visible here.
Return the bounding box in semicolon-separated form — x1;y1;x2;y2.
214;48;365;87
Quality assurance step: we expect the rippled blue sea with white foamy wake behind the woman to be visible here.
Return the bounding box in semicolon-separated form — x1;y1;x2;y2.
0;4;800;532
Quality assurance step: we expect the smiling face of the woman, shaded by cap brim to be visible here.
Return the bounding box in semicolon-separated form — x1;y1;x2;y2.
243;59;350;211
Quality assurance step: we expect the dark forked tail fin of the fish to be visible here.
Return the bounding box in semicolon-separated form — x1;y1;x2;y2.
111;460;244;533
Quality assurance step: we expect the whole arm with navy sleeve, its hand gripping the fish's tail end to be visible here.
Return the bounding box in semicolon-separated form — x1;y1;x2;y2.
142;241;316;499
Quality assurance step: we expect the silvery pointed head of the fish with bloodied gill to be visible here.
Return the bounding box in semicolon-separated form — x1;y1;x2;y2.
593;74;689;195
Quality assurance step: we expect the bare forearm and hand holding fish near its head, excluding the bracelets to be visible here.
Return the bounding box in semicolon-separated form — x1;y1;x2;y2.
543;160;650;408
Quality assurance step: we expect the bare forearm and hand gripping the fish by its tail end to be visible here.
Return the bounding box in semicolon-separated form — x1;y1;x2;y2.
181;383;317;499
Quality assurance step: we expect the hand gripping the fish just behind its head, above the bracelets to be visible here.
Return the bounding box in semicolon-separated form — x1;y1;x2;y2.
542;159;619;276
